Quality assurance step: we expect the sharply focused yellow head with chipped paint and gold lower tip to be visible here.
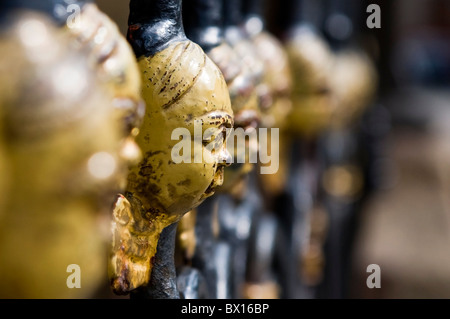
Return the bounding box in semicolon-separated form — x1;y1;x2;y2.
109;40;233;294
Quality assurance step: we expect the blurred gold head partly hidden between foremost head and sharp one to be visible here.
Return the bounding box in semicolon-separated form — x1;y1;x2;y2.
65;3;144;189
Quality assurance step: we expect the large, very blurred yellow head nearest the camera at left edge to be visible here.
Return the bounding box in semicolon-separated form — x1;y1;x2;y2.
0;14;122;298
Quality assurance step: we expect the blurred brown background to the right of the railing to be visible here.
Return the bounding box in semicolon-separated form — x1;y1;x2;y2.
97;0;450;298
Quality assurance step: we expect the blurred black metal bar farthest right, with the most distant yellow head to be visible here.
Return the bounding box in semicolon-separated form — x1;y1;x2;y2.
317;0;389;298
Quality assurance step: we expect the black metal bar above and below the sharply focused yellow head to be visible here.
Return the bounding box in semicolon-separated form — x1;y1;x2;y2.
127;0;186;299
